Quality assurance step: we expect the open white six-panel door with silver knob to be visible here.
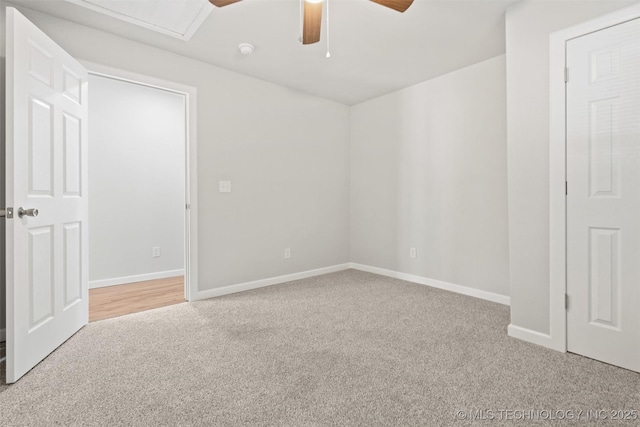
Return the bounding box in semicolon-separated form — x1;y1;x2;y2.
6;7;89;383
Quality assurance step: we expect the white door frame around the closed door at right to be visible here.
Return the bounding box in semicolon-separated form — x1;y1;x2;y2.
548;4;640;352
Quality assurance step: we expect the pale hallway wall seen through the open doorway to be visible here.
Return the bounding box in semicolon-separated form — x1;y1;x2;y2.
89;76;186;285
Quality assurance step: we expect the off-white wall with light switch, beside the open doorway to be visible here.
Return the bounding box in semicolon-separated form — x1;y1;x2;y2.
0;9;349;296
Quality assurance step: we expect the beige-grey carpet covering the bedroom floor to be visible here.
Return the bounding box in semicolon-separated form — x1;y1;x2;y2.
0;270;640;426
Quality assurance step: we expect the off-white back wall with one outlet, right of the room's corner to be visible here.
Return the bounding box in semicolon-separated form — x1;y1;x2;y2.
351;55;509;295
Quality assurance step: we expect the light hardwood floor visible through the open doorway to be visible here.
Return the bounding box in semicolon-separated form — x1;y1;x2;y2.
89;276;185;322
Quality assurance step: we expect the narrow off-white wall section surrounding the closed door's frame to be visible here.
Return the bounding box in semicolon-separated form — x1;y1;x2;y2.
506;0;635;334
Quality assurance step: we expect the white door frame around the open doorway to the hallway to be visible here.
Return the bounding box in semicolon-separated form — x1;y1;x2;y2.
78;59;198;301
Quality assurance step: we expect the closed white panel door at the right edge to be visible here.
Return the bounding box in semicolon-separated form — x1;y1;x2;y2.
566;16;640;371
